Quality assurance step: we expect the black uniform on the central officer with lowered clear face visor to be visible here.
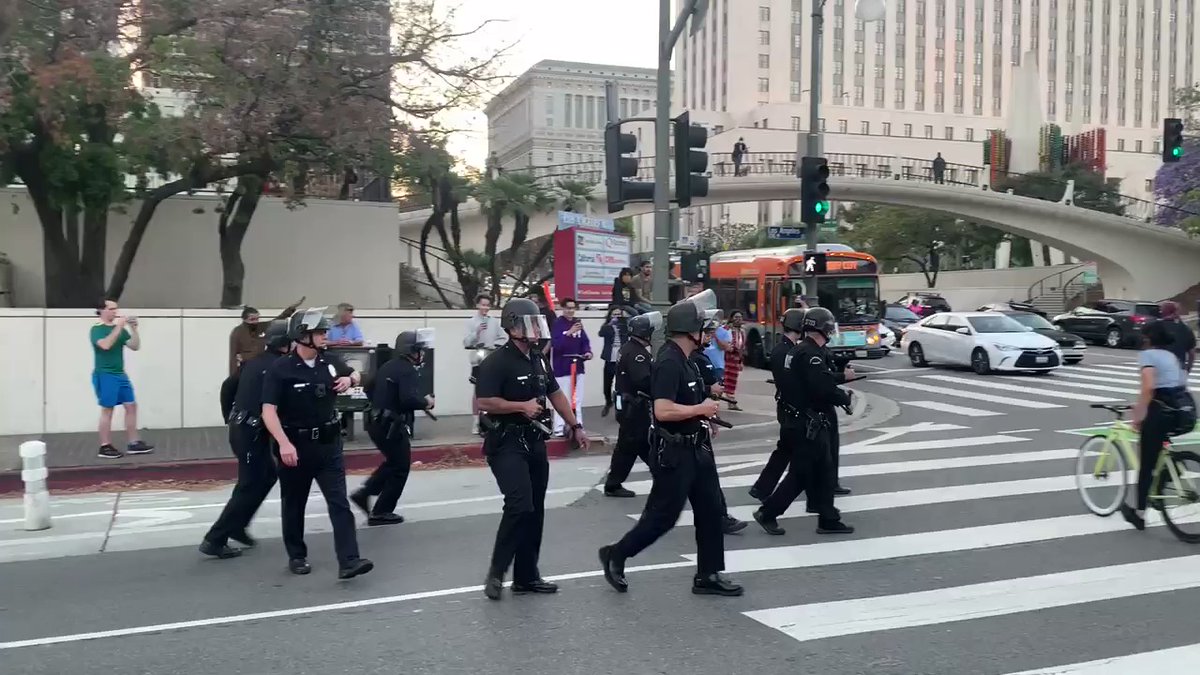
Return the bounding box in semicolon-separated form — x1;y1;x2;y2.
475;341;558;588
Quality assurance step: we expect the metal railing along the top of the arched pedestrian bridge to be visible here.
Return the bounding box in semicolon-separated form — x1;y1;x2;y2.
508;151;1200;227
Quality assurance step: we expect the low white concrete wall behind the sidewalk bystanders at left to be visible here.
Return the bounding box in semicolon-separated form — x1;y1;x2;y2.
0;307;604;436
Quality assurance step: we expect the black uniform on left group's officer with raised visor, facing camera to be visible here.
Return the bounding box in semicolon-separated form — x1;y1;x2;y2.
263;352;361;573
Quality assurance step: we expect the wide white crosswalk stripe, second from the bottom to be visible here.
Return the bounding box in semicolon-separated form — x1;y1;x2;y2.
745;556;1200;641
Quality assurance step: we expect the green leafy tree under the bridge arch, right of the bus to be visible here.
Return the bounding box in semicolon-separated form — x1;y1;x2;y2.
841;204;1004;288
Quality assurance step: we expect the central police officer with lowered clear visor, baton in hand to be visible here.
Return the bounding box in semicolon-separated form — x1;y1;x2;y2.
475;298;588;601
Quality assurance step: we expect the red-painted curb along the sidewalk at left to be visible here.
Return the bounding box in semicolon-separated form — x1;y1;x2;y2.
0;436;608;495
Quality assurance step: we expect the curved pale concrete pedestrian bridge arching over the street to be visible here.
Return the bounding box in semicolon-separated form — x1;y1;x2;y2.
401;155;1200;300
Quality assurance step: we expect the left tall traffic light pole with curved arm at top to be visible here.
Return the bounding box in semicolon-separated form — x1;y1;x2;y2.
650;0;708;309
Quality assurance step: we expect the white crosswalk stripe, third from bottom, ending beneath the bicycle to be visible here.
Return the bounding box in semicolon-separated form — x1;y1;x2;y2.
683;507;1176;571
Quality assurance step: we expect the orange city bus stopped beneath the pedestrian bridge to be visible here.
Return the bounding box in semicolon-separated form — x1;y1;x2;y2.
691;244;884;368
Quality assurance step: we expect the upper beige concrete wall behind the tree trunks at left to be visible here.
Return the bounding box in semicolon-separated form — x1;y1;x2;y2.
0;189;402;309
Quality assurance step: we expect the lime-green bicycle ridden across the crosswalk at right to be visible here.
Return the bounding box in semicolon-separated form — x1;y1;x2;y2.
1075;404;1200;544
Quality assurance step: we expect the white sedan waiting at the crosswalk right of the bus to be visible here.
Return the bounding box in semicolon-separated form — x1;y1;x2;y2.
900;312;1062;375
